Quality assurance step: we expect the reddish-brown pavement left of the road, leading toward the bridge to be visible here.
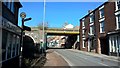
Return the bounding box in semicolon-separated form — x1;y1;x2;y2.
43;49;69;68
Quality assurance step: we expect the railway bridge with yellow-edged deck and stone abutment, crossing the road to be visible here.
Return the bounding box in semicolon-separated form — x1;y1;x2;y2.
25;27;80;48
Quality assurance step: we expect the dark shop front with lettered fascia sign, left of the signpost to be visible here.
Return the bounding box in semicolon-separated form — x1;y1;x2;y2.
2;17;21;68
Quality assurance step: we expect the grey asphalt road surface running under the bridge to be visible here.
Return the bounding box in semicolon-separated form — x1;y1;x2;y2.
54;49;120;68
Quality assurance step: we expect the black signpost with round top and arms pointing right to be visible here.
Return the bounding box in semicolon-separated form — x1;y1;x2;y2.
19;12;32;68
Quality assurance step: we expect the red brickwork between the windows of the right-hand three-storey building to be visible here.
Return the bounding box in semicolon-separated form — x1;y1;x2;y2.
80;2;116;53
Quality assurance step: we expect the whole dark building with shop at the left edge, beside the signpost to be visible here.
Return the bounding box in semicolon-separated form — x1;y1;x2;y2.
0;0;22;68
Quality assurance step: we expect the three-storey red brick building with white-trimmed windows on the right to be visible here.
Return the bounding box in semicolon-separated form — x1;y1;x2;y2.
80;2;120;55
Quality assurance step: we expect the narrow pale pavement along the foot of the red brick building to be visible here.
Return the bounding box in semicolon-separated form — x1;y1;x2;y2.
68;49;120;62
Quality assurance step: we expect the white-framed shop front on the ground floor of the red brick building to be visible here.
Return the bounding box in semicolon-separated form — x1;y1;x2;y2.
109;32;120;56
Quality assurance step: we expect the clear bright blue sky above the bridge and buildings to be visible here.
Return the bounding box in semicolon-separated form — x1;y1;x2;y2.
18;2;103;28
